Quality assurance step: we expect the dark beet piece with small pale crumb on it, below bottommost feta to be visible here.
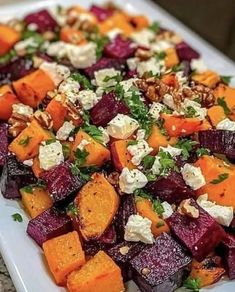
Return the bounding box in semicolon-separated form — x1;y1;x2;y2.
106;242;146;282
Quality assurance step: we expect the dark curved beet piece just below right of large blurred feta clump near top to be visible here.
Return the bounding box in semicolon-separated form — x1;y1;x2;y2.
84;58;126;79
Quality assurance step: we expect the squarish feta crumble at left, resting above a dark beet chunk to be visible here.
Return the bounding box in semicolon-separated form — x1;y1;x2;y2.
38;141;64;170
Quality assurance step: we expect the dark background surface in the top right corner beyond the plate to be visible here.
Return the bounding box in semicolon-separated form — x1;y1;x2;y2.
155;0;235;61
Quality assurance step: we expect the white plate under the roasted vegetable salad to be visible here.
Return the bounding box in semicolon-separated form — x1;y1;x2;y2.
0;0;235;292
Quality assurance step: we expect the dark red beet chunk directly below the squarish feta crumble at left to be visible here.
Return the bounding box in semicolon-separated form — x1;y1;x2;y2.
41;161;83;203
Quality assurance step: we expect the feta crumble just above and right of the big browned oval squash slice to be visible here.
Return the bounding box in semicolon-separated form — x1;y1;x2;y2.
119;167;148;194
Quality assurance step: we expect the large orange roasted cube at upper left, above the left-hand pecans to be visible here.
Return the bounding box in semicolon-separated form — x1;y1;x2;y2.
13;69;55;108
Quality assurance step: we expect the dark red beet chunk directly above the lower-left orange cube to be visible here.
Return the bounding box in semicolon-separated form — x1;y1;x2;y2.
27;207;72;246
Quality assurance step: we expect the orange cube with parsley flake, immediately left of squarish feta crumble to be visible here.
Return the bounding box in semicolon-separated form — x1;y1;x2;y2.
9;120;52;161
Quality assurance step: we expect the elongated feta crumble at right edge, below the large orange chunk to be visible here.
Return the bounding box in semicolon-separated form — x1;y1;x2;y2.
197;194;233;227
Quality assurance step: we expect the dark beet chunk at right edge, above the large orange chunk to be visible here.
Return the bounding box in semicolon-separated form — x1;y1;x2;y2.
198;130;235;159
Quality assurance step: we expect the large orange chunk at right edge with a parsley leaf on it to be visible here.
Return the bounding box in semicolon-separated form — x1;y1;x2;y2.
195;155;235;208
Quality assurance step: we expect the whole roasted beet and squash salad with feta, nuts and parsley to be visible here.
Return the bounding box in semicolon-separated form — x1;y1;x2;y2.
0;3;235;292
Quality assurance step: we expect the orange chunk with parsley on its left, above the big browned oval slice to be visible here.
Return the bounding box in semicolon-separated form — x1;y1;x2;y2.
72;130;110;166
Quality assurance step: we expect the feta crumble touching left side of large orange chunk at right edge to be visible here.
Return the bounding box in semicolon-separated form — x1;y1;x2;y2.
181;163;206;190
